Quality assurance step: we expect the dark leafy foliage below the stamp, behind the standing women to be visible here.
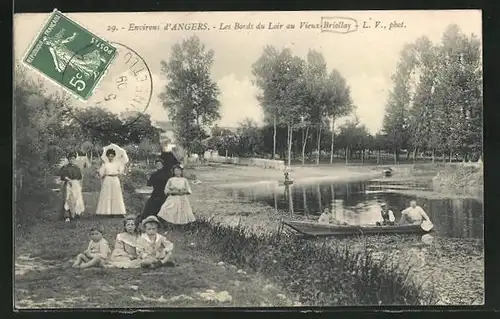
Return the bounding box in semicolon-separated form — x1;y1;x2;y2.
14;64;160;199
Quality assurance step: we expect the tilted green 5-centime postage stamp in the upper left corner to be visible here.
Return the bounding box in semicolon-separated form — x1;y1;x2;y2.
23;10;117;100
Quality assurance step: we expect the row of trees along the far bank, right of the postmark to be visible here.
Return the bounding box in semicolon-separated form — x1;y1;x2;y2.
161;25;482;164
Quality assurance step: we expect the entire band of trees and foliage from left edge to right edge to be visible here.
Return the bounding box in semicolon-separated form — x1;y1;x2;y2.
14;25;482;202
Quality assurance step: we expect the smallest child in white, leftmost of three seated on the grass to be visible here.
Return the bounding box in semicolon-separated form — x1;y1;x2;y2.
73;226;110;268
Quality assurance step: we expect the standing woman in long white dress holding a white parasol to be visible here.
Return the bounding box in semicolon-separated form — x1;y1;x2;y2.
96;149;125;216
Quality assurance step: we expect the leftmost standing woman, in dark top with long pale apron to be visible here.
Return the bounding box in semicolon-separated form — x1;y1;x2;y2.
59;154;85;222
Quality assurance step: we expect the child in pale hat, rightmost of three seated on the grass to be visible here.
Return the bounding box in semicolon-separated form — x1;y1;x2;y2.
137;216;174;268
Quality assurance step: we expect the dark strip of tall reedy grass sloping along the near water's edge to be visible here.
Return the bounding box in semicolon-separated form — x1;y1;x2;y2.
184;220;432;306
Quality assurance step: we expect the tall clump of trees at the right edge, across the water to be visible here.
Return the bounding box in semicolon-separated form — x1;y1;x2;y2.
383;25;482;165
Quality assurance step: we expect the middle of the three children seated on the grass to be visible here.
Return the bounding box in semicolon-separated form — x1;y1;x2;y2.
109;215;140;268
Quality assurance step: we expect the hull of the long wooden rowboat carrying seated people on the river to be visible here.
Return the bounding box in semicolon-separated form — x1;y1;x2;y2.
283;221;432;236
